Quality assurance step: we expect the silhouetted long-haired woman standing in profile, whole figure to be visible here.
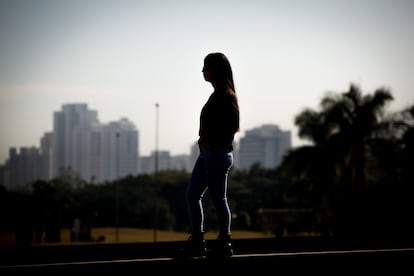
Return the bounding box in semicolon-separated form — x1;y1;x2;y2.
186;53;239;256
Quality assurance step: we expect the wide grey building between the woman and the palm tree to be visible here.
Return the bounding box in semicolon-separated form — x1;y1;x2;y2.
237;124;291;170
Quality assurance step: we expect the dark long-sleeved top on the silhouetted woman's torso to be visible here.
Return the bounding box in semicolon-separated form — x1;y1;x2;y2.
199;91;239;149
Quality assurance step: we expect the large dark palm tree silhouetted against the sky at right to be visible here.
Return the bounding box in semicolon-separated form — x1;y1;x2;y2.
295;84;393;237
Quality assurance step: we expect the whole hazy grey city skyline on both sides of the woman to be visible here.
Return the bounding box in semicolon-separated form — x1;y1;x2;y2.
0;103;291;189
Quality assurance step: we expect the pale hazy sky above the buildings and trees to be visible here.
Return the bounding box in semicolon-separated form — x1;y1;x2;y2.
0;0;414;164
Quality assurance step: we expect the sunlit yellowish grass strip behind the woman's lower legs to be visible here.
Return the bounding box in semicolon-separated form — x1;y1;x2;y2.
52;227;270;245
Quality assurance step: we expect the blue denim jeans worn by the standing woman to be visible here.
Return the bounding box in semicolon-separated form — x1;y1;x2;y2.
185;147;233;235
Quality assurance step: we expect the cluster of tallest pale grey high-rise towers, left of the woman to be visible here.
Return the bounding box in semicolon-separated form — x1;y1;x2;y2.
52;104;138;183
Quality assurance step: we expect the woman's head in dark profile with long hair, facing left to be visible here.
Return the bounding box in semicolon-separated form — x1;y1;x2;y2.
203;53;235;92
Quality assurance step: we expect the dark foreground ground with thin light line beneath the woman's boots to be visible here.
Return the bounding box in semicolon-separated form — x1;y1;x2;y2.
0;237;414;276
